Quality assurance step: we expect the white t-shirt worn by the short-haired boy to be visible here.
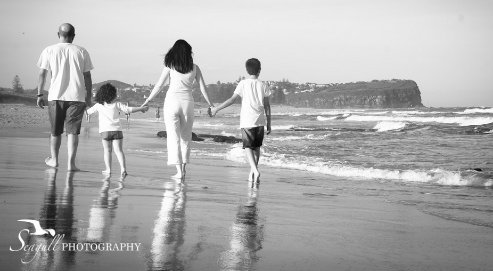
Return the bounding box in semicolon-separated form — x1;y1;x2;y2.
234;78;272;128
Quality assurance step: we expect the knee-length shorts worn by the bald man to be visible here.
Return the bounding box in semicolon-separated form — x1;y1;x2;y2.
48;100;86;136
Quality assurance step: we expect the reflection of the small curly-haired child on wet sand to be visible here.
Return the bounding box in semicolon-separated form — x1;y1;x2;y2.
86;176;125;242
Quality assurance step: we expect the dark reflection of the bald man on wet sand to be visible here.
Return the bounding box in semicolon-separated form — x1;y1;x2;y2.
22;169;76;270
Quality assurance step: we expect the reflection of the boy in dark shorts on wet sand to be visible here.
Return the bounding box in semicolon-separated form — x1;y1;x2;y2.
220;184;264;270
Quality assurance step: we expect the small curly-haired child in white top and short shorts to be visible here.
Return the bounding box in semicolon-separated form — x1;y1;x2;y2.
86;83;149;177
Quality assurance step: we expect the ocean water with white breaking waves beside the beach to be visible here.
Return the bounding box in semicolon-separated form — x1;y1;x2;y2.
131;107;493;228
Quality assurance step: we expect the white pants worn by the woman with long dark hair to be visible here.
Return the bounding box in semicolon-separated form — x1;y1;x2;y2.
163;97;194;165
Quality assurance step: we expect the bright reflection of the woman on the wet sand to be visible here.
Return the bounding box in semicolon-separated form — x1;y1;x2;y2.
148;182;186;270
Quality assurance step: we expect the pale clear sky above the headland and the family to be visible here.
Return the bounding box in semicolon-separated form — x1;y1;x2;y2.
0;0;493;107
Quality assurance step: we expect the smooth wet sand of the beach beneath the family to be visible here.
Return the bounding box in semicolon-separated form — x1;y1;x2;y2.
0;113;493;270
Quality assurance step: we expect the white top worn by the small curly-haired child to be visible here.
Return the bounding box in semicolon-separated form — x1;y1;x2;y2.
87;103;132;133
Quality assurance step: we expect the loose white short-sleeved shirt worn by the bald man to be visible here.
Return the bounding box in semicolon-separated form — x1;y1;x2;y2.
38;43;94;102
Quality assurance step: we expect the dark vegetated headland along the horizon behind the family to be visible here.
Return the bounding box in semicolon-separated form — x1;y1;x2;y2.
0;76;423;108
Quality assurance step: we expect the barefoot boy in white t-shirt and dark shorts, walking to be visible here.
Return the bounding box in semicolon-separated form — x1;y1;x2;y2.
211;58;272;183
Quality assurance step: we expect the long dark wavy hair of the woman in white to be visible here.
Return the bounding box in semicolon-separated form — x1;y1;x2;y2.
164;40;193;73
